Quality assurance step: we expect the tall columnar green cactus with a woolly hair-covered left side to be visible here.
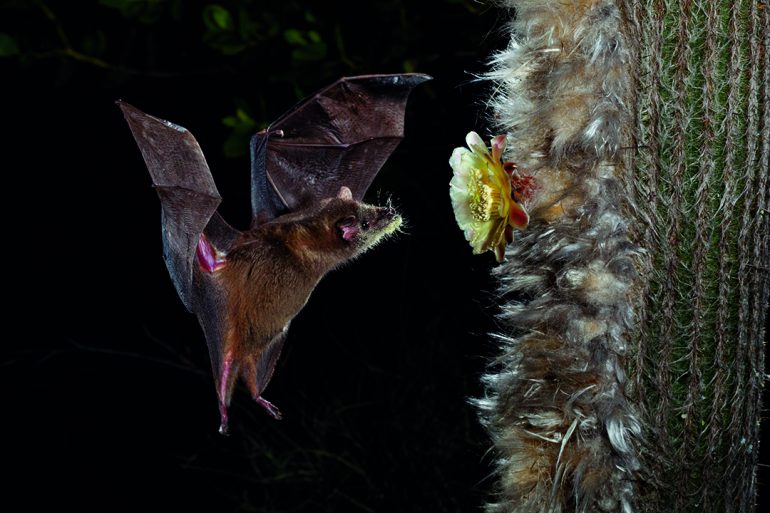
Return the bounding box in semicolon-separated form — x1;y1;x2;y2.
476;0;770;513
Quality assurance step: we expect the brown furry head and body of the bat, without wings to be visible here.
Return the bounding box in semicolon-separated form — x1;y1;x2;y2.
216;193;401;422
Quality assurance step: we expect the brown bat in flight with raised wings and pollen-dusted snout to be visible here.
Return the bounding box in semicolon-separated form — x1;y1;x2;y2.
118;74;430;434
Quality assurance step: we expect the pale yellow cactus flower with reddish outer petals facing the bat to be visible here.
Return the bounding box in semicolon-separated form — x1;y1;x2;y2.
449;132;532;262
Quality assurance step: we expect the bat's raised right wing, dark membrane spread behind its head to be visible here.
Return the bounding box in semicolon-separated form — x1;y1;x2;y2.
251;74;430;220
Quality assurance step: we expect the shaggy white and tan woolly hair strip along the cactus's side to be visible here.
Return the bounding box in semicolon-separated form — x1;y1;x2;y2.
475;0;646;513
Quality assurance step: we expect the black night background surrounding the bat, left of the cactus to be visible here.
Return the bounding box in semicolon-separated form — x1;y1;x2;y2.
0;0;766;512
